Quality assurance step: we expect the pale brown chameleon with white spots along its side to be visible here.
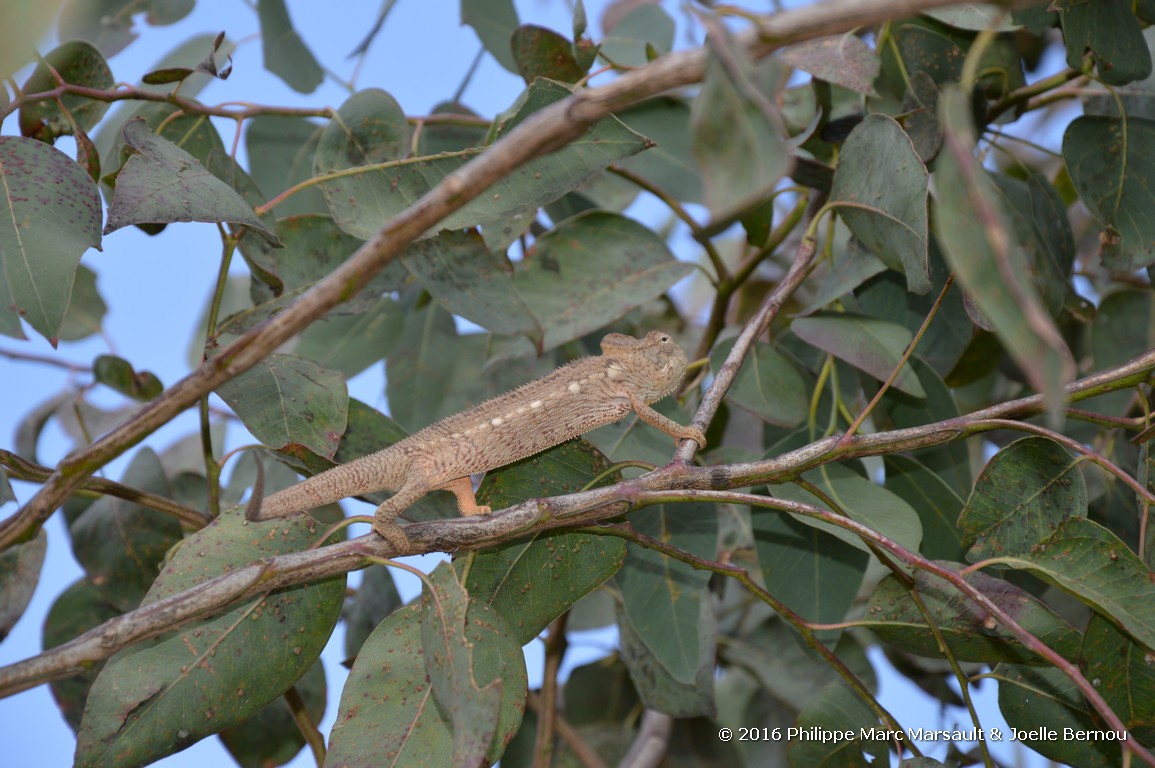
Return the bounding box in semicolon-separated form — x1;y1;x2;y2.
246;330;706;552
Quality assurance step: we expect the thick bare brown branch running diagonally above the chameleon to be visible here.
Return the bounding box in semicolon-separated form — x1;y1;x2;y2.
0;0;1021;551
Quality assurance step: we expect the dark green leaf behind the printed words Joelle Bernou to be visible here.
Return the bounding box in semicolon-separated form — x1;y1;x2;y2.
994;664;1119;768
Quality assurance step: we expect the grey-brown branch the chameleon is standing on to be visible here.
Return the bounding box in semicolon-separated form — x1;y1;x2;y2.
0;350;1155;696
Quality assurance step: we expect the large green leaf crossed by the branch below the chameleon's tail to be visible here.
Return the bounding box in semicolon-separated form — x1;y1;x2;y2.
76;509;345;768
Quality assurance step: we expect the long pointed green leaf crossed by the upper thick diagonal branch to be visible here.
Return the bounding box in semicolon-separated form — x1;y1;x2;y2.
318;80;648;239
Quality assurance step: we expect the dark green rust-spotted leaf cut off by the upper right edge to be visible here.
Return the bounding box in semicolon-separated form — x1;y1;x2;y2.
1063;115;1155;271
